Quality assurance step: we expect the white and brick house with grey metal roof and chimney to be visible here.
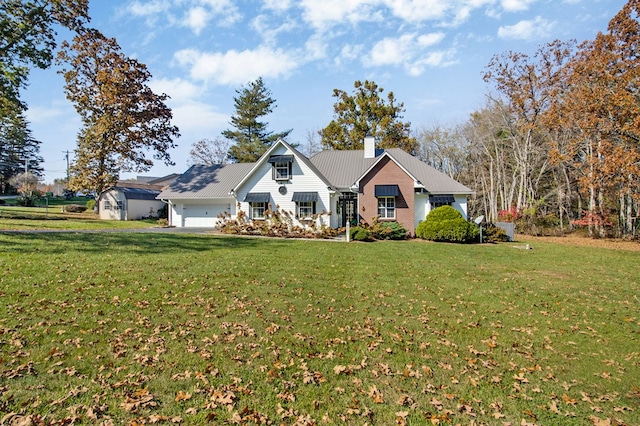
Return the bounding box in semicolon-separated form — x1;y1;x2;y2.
157;137;472;234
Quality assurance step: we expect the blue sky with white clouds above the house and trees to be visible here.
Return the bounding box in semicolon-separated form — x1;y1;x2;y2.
24;0;626;182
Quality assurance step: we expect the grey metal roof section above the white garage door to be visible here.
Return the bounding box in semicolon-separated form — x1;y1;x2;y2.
157;163;255;200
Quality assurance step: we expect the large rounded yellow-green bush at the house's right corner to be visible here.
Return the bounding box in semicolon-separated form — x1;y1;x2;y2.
416;206;479;243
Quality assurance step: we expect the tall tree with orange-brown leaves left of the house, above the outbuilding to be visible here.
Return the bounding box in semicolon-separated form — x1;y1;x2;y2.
58;29;179;201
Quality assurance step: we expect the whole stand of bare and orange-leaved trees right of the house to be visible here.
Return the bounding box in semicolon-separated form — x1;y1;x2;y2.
465;0;640;237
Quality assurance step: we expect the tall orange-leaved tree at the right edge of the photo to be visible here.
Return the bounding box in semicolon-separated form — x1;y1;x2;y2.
547;0;640;237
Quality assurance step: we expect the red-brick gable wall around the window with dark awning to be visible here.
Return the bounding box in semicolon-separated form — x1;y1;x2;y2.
358;157;415;235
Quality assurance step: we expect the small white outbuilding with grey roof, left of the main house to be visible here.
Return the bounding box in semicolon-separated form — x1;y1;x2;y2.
98;181;164;220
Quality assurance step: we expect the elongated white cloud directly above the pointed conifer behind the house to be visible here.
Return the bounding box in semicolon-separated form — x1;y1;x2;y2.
174;46;299;85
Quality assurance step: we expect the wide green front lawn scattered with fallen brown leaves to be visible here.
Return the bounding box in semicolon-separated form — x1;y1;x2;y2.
0;233;640;425
